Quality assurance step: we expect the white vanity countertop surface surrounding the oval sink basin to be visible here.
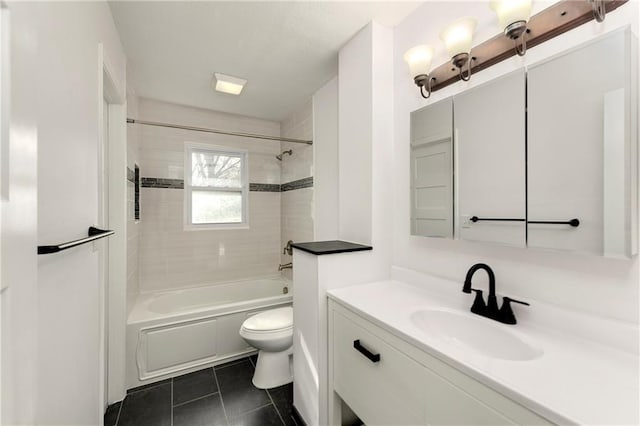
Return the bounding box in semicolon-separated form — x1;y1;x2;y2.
328;277;640;425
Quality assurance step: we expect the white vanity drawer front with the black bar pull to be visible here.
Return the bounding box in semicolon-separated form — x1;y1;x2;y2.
333;311;426;426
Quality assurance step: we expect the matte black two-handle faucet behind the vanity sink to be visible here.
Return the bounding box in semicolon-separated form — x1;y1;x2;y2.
462;263;529;324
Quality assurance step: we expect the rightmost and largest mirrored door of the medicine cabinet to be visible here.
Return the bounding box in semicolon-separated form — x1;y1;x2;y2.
528;31;631;255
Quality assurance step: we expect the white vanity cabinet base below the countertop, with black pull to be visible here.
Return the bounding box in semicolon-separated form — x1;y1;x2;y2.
329;300;550;426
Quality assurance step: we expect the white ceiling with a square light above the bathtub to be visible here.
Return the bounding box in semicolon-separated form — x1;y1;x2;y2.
109;1;421;121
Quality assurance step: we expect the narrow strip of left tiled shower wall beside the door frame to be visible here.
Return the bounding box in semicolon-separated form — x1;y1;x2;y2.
127;93;140;312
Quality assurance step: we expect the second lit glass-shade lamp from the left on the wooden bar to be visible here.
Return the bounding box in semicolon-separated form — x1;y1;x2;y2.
440;17;478;81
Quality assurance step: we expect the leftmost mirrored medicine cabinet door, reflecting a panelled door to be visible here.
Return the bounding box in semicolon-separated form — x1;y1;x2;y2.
411;98;453;238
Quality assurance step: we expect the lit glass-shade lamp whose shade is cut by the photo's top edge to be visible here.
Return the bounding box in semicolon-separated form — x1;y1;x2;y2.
490;0;531;56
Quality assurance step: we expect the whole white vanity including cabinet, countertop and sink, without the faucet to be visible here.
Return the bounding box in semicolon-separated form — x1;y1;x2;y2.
328;268;640;425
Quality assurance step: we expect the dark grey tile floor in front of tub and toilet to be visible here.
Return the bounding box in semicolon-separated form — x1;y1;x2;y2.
104;356;297;426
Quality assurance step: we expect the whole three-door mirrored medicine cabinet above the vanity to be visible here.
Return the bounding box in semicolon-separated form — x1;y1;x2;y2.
410;28;638;258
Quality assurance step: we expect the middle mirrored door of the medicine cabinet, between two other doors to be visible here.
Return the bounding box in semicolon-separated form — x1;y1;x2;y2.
453;70;526;247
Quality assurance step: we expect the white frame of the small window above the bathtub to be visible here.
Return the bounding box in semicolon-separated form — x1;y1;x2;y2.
183;142;249;231
